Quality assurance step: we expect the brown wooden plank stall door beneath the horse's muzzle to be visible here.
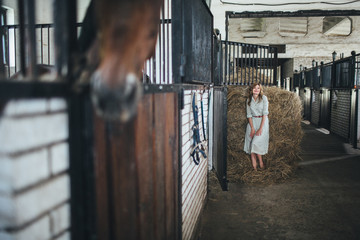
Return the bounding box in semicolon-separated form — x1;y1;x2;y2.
94;93;181;240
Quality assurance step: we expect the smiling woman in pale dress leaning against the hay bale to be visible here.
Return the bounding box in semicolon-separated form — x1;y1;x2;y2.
244;83;269;171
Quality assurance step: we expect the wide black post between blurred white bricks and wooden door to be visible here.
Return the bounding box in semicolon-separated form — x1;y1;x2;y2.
65;87;96;240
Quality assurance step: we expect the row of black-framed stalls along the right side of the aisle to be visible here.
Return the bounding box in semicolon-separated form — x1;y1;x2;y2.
296;52;359;148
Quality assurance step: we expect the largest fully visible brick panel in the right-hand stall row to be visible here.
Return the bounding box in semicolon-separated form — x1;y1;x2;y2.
330;90;351;139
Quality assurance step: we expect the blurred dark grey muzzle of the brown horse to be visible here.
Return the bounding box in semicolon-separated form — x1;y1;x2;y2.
91;71;142;122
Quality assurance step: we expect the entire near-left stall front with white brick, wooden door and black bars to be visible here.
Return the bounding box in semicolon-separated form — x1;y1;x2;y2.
0;0;213;240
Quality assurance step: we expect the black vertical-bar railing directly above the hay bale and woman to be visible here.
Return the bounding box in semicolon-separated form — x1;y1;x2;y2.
220;41;277;85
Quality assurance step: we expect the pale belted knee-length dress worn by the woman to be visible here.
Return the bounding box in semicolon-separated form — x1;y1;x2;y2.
244;95;269;155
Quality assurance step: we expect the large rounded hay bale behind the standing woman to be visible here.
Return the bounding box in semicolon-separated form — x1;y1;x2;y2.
227;86;303;184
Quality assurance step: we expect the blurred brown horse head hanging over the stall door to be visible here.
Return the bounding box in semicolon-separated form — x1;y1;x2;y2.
91;0;163;121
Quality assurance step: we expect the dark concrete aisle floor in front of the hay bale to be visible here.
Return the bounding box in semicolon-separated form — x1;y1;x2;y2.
198;124;360;240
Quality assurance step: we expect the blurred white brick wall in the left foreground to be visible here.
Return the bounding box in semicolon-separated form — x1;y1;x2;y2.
0;98;70;240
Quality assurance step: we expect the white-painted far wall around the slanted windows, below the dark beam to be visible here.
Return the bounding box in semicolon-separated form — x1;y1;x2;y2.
229;16;360;61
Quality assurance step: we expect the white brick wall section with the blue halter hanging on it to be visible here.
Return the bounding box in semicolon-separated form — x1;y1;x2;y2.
181;90;208;240
